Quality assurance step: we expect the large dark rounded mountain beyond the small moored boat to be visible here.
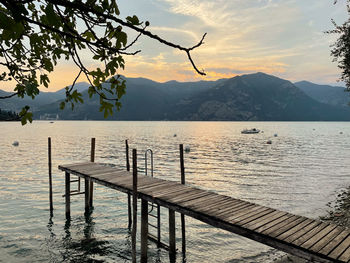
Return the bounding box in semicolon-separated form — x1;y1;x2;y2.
167;73;350;121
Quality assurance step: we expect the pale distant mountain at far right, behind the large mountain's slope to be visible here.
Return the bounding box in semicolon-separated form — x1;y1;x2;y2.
294;81;350;107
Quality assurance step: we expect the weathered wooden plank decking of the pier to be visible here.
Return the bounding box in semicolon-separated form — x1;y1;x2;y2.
58;162;350;262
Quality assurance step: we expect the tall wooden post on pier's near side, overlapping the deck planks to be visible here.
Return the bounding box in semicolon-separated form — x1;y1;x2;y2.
131;149;137;263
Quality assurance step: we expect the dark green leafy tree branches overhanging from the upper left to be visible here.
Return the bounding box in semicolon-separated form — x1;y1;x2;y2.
0;0;205;124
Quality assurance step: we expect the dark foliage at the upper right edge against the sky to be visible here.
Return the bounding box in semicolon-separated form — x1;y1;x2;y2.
326;0;350;91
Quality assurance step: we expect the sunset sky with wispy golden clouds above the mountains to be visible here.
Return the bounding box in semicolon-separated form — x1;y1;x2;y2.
1;0;347;91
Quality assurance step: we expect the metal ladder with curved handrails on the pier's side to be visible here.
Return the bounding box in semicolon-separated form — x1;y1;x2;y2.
145;149;163;247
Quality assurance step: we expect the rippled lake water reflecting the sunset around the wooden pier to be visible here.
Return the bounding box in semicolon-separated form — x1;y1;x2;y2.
0;121;350;262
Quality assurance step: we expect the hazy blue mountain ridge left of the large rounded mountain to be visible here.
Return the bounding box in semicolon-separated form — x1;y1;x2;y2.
35;77;223;120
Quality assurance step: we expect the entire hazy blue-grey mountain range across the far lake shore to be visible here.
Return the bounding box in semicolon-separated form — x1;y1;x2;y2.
0;72;350;121
